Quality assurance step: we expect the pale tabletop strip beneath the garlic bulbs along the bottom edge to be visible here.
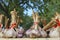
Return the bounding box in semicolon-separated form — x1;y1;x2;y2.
0;38;60;40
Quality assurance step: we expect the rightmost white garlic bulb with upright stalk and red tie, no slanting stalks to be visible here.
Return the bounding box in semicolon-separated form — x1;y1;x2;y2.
49;13;60;38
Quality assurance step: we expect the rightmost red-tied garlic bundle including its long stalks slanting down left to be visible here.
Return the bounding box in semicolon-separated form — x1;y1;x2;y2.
43;13;60;38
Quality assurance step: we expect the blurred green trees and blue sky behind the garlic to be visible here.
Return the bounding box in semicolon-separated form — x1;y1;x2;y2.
0;0;60;29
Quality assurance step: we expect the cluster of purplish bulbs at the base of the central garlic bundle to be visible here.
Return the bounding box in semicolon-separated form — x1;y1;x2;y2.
26;27;47;38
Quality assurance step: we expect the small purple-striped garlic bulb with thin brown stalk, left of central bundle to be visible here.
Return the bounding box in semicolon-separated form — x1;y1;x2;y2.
15;16;24;38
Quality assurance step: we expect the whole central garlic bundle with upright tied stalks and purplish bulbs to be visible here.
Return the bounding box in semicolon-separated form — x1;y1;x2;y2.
26;12;47;38
